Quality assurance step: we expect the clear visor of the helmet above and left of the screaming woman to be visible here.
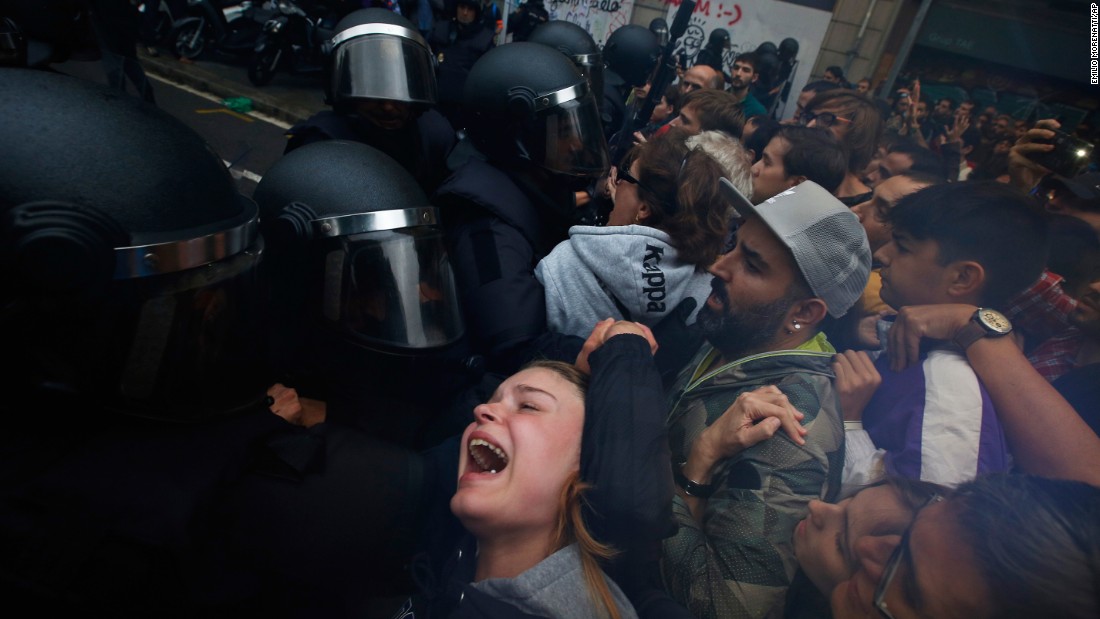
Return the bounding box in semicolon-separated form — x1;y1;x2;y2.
323;226;464;350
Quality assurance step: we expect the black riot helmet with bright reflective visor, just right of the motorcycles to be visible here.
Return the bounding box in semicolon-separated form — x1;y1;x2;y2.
326;8;438;109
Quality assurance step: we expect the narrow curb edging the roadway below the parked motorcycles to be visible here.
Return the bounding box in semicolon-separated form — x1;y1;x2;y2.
138;49;328;125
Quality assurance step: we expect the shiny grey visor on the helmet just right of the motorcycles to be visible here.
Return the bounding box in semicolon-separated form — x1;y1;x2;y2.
332;34;438;106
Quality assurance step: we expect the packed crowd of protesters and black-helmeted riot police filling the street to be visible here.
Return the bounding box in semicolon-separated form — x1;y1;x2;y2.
0;0;1100;619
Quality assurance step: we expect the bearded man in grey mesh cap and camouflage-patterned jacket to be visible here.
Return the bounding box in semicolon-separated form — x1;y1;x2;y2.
598;179;871;617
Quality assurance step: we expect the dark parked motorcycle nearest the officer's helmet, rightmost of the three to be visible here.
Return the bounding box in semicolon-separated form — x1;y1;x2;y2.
249;0;339;86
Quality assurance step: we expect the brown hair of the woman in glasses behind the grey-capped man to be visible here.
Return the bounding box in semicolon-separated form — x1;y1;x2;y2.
800;89;884;207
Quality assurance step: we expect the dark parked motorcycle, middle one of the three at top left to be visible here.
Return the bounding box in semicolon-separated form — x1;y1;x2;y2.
173;0;272;60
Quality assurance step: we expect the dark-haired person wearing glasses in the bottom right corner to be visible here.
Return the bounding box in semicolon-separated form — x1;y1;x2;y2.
822;474;1100;619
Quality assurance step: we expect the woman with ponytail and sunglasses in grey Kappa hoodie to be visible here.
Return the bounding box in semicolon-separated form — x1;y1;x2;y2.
535;129;751;336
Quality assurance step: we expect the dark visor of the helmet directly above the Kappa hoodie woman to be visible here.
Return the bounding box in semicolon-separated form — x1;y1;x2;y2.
524;93;609;178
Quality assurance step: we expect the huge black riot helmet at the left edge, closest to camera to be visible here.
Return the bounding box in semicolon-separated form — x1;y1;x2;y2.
0;68;268;421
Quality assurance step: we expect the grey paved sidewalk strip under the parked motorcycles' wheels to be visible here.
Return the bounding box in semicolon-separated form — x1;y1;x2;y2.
138;48;329;124
